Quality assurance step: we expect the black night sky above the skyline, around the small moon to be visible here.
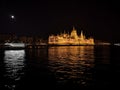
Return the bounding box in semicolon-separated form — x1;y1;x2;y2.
0;0;120;42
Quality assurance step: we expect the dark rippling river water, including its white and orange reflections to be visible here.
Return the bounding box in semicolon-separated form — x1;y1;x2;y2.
0;46;120;90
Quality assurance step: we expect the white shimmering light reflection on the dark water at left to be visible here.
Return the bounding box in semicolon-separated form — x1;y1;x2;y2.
4;50;25;90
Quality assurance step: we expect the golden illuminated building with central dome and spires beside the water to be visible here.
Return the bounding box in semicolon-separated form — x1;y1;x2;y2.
48;27;94;45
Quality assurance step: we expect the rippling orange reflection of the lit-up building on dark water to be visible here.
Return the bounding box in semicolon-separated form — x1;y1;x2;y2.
48;46;94;86
